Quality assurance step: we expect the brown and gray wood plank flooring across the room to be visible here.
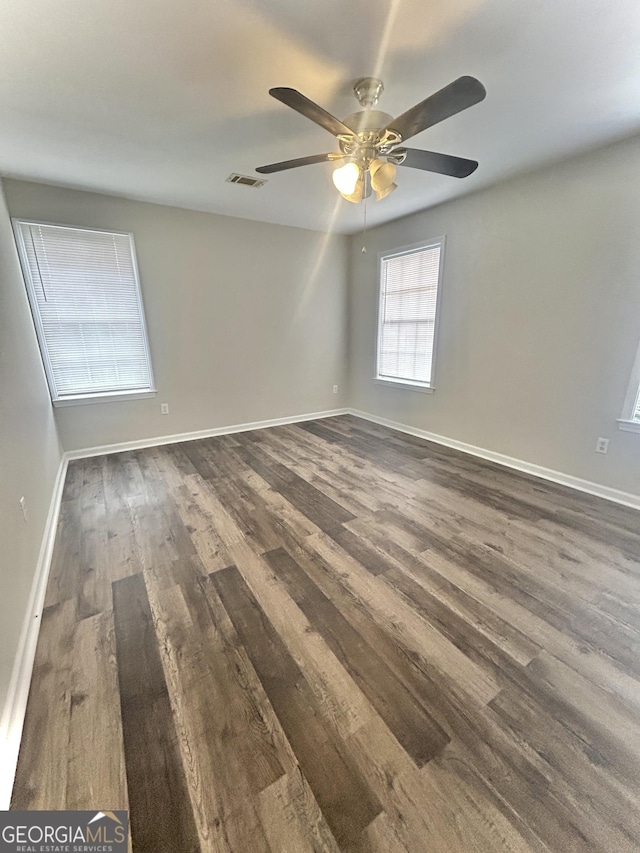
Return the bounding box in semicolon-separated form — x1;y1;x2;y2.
12;416;640;853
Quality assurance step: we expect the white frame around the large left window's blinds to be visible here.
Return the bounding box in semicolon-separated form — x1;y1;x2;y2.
11;216;157;408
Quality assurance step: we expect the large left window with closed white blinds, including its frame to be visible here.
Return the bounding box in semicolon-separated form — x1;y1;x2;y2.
14;220;155;405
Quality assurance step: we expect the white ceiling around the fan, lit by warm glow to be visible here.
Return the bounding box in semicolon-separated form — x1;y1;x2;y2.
0;0;640;233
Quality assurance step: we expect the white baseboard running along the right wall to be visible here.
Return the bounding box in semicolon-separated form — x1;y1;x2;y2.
349;409;640;510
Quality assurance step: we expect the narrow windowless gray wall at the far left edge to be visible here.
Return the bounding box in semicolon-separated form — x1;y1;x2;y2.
0;184;62;711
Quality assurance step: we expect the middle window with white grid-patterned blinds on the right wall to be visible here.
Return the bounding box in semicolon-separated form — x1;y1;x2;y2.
376;237;444;390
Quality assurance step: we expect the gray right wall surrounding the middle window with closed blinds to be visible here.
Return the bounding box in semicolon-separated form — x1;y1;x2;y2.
349;132;640;494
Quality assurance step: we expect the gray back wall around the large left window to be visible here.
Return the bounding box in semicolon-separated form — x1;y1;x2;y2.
5;180;347;450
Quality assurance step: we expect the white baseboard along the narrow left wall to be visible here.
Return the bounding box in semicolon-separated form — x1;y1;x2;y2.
0;454;68;809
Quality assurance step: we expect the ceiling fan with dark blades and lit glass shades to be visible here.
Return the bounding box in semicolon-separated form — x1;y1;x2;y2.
256;77;487;204
